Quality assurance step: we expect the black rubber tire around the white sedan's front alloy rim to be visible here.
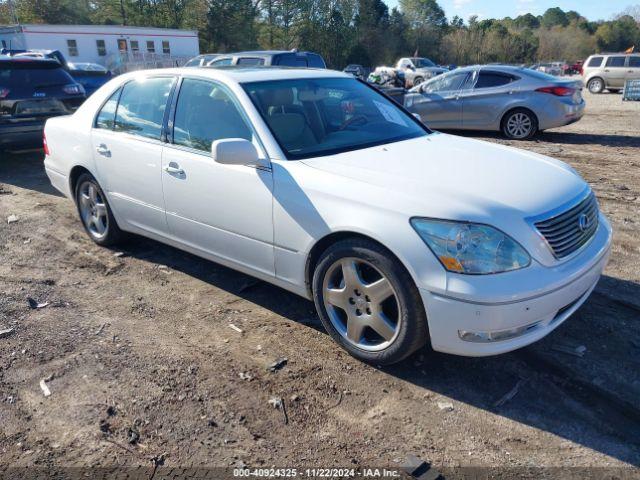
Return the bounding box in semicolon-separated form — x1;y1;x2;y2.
312;238;429;365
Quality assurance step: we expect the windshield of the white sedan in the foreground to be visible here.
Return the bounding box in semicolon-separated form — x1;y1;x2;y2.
243;78;429;160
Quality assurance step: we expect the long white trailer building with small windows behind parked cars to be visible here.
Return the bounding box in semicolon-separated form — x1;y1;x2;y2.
0;25;200;71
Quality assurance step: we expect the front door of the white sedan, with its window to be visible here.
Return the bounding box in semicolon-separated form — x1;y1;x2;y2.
162;78;274;275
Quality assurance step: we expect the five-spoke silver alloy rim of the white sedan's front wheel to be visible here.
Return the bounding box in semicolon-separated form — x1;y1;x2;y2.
322;257;400;351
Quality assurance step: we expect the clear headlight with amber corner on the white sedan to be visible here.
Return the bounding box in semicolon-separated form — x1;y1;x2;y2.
411;218;531;275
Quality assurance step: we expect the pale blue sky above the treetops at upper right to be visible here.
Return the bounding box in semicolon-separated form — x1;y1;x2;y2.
385;0;640;22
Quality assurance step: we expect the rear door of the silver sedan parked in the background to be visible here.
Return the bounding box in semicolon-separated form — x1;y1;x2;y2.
462;70;518;130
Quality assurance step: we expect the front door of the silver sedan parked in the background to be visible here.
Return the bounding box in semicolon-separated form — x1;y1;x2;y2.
405;71;469;129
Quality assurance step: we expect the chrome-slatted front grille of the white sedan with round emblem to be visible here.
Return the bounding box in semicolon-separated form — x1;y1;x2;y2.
535;193;598;258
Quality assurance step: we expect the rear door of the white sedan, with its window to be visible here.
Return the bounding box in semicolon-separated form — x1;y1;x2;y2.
91;76;176;235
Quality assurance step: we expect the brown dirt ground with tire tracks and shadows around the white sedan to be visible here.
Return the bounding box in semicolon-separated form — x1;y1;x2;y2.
0;89;640;478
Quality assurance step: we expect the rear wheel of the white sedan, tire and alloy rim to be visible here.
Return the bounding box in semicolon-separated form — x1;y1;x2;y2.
76;173;123;247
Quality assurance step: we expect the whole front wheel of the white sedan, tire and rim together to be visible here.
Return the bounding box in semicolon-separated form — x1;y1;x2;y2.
313;239;428;365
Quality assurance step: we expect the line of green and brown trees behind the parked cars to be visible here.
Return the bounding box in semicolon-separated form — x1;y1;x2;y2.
0;0;640;68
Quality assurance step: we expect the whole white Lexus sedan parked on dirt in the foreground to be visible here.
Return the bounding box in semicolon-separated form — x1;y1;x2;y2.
45;68;611;365
